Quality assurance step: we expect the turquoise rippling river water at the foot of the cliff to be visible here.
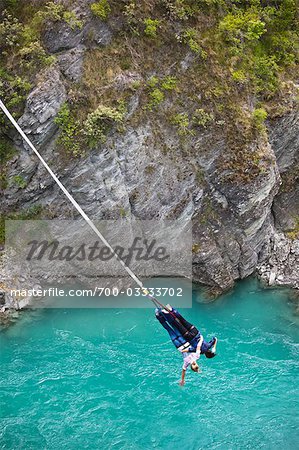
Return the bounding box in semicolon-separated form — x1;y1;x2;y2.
0;279;299;450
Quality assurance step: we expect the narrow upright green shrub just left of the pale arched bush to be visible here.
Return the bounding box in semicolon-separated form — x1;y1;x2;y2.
54;103;82;157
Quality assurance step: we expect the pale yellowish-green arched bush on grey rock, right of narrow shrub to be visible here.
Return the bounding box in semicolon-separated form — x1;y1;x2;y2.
83;105;124;147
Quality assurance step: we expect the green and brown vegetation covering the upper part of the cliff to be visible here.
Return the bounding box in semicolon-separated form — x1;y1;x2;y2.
0;0;298;155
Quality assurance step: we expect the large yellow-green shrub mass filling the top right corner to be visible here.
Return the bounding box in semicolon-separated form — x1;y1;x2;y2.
218;0;298;98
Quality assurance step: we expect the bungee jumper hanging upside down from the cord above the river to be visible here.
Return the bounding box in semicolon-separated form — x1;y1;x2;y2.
155;305;217;386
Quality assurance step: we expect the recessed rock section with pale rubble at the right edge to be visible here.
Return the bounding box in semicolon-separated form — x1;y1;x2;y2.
258;110;299;289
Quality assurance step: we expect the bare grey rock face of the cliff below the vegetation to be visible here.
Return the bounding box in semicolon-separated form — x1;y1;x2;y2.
1;2;299;310
